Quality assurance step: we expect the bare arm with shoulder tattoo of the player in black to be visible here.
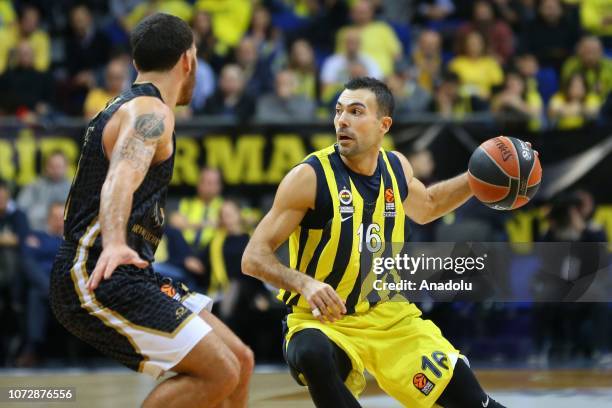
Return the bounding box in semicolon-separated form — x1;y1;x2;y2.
87;97;174;290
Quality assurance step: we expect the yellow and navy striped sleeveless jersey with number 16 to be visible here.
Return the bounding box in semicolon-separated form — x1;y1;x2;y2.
278;145;408;313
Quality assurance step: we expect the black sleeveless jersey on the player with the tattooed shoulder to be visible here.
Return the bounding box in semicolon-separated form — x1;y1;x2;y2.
64;83;175;262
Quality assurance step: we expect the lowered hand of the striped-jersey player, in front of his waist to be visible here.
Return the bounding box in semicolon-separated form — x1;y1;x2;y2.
301;279;346;323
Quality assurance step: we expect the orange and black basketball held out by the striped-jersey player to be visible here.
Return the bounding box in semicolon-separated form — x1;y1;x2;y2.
468;136;542;210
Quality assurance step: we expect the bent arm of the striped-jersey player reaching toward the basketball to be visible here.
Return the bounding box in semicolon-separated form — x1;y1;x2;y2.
393;152;472;224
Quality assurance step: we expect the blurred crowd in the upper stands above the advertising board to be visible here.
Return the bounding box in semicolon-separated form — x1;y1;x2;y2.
0;0;612;130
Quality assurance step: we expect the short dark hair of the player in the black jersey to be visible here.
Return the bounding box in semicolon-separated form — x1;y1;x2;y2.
130;13;193;72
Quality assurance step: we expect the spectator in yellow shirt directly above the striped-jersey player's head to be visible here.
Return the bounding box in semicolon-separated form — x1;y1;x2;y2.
336;0;402;76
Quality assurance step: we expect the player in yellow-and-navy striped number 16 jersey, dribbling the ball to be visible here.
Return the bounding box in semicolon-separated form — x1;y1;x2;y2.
242;78;502;408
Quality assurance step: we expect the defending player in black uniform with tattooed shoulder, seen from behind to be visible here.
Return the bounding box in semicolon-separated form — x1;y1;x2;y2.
51;14;253;408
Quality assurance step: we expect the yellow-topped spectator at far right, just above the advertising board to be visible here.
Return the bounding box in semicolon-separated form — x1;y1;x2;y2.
548;74;601;130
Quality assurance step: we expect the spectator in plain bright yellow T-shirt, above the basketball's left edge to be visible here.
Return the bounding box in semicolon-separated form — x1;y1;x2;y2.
449;31;504;99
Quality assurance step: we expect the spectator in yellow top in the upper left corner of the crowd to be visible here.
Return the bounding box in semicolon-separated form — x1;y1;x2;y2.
0;5;51;74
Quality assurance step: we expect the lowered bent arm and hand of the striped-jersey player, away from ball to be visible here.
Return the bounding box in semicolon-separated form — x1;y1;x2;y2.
242;164;346;322
